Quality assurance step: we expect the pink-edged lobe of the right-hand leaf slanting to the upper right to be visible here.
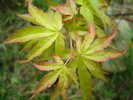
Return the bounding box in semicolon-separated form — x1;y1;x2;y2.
85;30;117;54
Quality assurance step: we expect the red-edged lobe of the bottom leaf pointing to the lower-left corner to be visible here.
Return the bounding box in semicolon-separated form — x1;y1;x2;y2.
30;69;62;99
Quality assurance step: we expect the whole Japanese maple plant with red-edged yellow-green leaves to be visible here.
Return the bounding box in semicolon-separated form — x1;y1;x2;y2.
4;0;127;100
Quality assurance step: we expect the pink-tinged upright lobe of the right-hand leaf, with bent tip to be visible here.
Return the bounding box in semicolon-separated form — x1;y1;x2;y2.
82;22;96;51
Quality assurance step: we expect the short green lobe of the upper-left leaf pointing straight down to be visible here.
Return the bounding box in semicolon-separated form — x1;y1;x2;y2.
55;34;65;56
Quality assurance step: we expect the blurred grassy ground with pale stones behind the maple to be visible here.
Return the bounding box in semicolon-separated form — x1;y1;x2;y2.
0;0;133;100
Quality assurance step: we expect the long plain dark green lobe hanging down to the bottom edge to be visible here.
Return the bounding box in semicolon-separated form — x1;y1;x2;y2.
78;57;92;100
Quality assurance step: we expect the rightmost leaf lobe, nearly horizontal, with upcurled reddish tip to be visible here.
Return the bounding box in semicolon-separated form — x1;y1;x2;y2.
85;48;127;62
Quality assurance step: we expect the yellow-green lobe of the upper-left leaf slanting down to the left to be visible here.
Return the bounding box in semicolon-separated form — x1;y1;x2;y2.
27;34;58;61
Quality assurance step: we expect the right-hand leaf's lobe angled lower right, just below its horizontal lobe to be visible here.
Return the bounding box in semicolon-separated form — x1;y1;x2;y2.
82;57;107;74
